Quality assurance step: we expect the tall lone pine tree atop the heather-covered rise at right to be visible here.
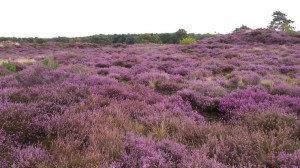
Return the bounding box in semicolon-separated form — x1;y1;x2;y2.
269;11;294;31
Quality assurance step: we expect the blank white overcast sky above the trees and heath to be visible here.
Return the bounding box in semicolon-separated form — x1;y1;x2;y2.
0;0;300;37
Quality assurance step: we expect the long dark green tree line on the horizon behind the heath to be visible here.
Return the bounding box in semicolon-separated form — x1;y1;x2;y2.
0;29;217;45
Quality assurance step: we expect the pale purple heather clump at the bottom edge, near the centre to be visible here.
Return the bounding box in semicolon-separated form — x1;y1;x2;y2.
113;135;191;167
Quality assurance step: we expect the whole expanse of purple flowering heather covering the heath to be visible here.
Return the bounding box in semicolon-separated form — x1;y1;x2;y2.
0;29;300;168
